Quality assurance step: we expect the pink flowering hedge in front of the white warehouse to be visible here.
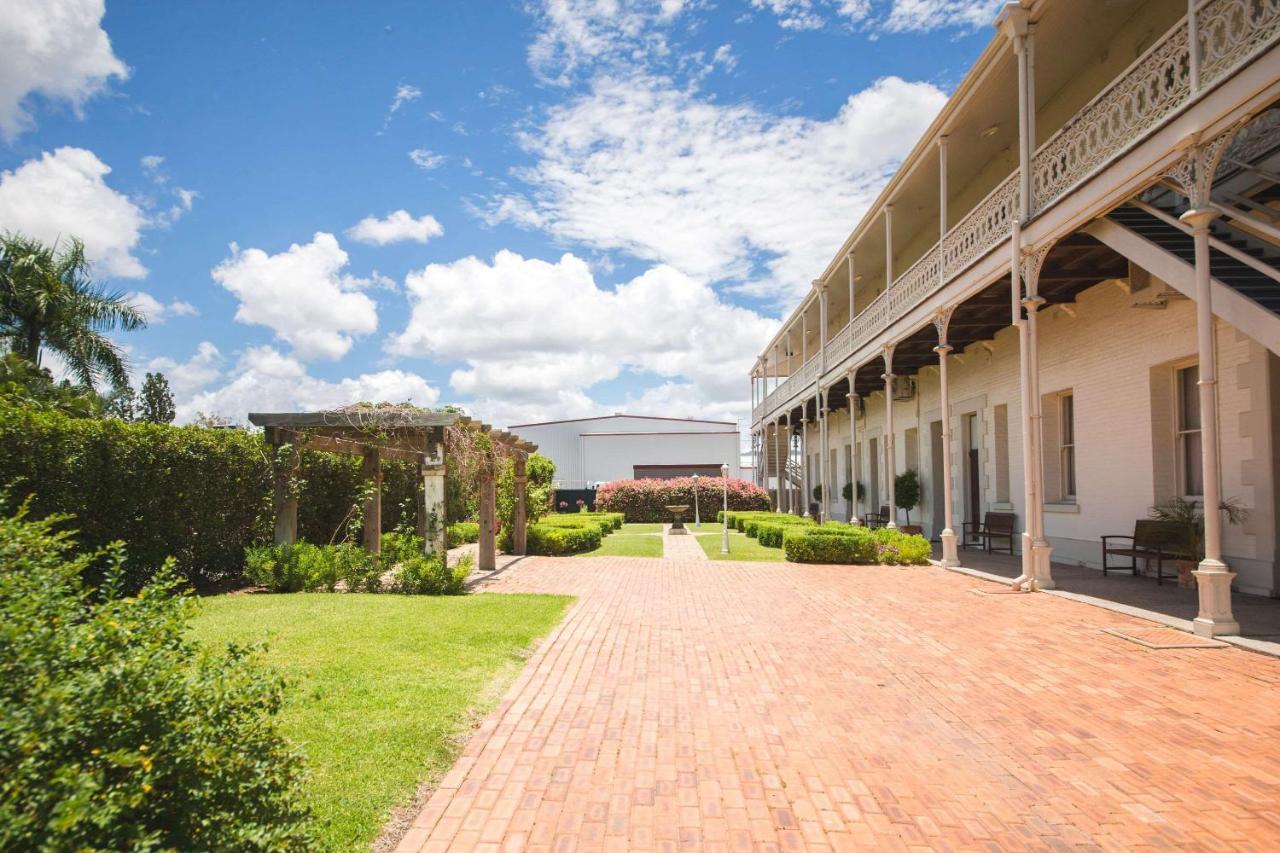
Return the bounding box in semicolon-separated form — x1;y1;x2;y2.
595;476;769;523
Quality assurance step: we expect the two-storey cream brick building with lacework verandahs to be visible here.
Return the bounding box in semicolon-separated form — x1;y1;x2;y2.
751;0;1280;635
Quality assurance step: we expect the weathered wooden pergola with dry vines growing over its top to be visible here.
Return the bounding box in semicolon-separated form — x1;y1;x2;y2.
248;406;538;571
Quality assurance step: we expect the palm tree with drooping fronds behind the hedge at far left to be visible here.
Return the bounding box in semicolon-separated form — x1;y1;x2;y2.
0;234;147;388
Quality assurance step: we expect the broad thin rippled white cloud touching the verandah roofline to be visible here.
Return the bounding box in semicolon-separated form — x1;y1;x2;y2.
485;77;946;295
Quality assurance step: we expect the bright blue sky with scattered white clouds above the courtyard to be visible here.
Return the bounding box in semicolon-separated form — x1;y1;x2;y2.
0;0;1001;424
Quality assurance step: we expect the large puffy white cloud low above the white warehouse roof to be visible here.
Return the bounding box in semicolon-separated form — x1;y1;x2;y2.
388;251;777;423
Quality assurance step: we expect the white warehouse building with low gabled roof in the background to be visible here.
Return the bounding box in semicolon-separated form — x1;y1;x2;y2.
507;414;742;489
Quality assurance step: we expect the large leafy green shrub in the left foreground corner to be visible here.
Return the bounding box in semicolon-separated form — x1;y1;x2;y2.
0;499;312;850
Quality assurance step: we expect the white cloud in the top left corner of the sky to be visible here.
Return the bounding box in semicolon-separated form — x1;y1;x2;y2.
0;0;129;140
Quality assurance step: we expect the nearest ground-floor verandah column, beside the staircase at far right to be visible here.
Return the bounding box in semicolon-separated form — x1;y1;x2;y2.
1181;206;1240;637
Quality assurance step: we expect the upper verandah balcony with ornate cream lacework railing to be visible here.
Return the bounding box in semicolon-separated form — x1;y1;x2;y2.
753;0;1280;421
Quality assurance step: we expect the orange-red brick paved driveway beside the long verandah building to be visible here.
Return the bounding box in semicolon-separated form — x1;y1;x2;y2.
401;558;1280;850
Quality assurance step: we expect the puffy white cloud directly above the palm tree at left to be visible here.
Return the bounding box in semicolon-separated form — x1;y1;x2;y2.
0;147;150;278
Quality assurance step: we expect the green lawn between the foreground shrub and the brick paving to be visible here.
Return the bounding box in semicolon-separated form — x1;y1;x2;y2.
195;593;572;850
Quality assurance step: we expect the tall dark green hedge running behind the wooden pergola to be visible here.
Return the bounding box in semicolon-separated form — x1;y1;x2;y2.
0;403;416;592
